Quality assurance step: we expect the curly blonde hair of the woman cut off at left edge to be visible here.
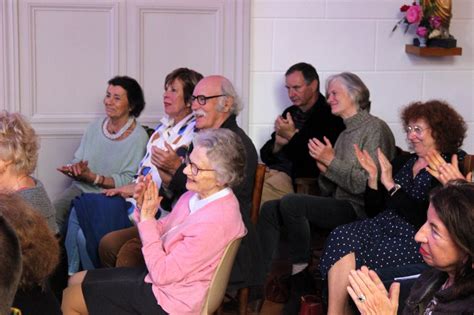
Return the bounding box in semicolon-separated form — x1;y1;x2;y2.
0;111;39;175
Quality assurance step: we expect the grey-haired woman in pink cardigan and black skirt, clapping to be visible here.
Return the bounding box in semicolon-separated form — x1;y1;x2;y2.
62;129;246;315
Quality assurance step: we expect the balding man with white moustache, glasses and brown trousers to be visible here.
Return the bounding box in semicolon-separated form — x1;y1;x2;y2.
99;75;263;300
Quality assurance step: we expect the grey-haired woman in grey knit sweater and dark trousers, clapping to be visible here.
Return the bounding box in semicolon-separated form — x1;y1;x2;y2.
257;72;395;314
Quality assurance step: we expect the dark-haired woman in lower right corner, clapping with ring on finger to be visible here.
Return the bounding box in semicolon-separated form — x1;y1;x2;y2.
347;180;474;314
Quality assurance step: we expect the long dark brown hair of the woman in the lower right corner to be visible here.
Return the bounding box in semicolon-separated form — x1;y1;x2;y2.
430;180;474;300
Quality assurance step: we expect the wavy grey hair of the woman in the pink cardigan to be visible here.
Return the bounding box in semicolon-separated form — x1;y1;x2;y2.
193;128;246;188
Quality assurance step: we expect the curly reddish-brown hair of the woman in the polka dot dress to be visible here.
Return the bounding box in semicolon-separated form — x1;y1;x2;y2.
401;100;467;154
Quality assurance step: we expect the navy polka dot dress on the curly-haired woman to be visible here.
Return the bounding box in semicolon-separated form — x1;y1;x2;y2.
320;157;432;278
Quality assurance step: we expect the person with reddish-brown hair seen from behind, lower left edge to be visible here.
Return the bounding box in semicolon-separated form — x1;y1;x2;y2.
0;193;60;314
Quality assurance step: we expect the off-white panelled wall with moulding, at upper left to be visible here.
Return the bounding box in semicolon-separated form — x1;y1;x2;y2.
0;0;250;198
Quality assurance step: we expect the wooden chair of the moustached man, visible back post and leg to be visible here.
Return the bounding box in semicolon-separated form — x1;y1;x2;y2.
237;163;266;315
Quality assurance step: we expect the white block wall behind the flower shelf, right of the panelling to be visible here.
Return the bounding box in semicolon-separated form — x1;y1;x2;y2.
249;0;474;153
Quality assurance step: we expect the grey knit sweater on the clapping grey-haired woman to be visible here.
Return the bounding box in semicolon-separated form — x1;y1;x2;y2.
319;110;395;218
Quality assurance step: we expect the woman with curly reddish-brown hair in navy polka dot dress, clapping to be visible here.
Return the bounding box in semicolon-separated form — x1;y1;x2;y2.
320;100;467;314
